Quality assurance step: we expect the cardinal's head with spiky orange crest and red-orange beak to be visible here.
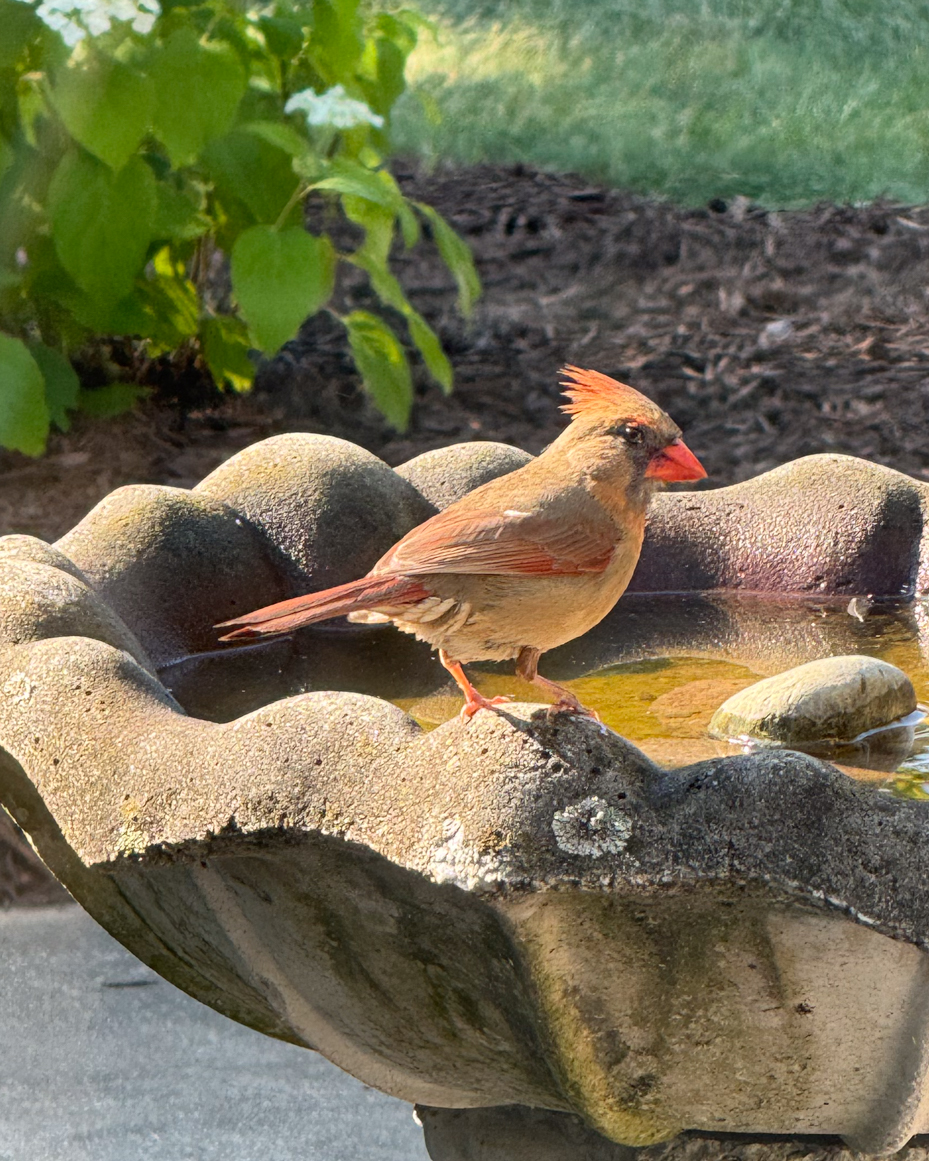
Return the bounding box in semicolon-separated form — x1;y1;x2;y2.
561;366;706;492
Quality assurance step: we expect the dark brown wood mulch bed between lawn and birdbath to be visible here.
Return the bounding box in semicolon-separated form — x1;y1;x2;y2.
0;165;929;903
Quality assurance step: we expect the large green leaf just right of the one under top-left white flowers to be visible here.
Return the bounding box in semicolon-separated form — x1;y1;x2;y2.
150;28;245;168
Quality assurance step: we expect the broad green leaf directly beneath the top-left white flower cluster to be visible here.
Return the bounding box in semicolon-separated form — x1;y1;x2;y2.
51;50;154;170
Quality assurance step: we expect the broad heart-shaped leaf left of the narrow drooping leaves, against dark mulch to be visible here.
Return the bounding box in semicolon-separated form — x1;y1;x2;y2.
232;225;336;354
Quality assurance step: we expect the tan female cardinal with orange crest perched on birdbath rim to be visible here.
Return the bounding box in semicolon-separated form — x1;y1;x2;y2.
217;367;706;719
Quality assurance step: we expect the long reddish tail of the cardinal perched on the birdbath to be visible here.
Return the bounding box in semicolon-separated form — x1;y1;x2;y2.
216;576;429;641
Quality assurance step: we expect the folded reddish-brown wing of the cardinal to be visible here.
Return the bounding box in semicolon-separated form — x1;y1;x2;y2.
372;507;622;576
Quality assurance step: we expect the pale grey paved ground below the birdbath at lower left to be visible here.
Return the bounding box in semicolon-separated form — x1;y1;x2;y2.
0;906;426;1161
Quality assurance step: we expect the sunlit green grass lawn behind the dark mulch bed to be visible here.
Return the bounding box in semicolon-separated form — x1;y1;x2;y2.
396;0;929;207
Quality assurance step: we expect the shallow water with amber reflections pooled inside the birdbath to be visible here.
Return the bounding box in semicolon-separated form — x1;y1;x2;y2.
160;594;929;801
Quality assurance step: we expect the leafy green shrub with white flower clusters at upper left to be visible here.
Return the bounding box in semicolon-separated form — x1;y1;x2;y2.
0;0;480;455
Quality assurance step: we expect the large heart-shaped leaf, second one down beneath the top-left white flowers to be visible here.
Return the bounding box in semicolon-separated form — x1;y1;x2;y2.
49;152;157;307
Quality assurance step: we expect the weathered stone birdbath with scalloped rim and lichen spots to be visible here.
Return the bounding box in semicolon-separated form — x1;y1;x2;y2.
0;434;929;1161
